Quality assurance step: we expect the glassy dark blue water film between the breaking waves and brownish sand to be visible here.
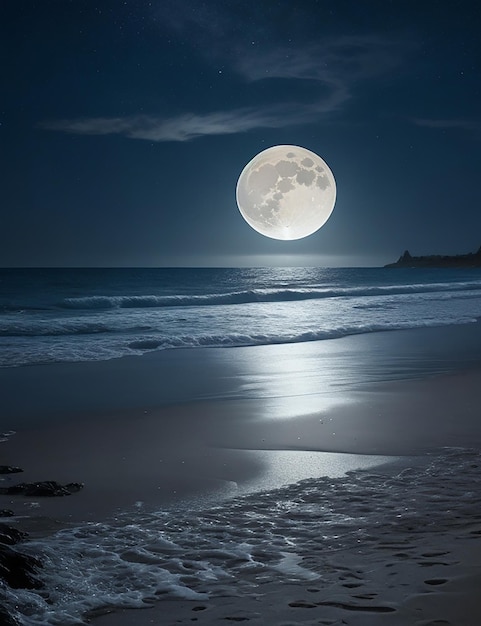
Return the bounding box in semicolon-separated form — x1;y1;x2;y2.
0;318;481;431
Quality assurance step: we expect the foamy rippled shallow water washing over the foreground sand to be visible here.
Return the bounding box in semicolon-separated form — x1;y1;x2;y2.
2;449;481;626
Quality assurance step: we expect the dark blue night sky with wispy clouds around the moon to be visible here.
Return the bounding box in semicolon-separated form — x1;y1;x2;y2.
0;0;481;266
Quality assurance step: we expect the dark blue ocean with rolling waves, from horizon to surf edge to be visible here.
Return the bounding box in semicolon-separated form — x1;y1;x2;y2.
0;268;481;367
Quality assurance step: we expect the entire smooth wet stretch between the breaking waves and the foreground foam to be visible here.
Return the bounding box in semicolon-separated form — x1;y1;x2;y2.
0;323;481;521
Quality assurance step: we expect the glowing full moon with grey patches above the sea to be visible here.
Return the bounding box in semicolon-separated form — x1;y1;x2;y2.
236;146;336;240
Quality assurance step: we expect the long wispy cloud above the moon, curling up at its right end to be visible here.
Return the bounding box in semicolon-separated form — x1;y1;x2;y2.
39;37;412;142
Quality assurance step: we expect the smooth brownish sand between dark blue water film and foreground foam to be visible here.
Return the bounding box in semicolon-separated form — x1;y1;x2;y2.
0;360;481;523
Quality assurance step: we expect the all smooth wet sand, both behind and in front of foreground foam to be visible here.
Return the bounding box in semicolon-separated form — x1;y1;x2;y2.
0;324;481;626
